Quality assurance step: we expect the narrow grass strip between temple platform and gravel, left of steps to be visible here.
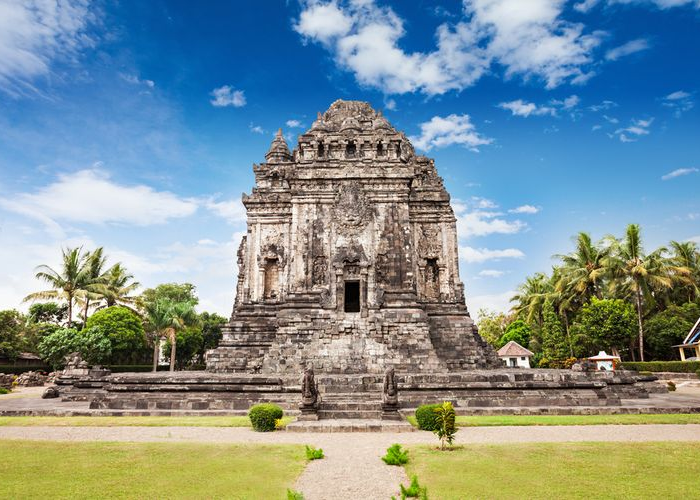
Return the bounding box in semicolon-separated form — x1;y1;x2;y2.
0;416;294;427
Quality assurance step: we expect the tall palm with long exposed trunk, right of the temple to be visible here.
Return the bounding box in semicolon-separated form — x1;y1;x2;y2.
606;224;673;361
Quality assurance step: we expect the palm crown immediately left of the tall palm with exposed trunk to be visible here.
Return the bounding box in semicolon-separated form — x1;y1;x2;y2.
556;232;610;304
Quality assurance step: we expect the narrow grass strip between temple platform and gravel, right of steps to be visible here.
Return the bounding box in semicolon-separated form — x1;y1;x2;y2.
408;413;700;427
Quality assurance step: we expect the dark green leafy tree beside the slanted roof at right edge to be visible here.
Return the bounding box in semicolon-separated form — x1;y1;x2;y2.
644;302;700;360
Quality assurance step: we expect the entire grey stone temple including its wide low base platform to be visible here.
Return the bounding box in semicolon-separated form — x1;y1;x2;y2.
85;101;654;421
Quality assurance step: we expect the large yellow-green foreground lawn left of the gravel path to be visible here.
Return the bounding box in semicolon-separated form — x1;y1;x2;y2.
0;441;307;499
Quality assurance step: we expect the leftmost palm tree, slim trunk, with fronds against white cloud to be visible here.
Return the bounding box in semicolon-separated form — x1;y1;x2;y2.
23;247;88;328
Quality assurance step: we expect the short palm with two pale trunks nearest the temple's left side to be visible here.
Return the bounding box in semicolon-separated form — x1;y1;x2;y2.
144;299;197;372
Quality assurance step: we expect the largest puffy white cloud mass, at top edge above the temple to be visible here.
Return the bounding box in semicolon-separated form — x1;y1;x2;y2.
294;0;602;95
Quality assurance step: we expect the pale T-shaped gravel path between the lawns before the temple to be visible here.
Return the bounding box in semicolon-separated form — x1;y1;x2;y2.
0;424;700;500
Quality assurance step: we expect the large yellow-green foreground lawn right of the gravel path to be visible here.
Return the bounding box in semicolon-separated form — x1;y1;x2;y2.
405;442;700;499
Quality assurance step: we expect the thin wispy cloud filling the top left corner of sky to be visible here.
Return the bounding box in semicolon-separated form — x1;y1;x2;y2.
0;0;95;97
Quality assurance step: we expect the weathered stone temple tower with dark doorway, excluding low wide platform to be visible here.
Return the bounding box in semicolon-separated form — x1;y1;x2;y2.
207;100;501;374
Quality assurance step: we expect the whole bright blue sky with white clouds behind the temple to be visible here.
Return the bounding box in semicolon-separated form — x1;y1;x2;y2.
0;0;700;315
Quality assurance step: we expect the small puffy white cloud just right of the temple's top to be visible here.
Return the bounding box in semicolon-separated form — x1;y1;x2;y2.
410;115;493;151
